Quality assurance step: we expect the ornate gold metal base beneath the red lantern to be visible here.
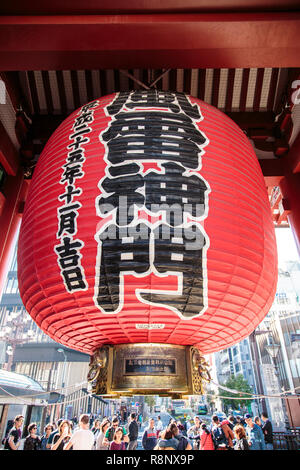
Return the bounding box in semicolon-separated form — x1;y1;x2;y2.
88;343;210;399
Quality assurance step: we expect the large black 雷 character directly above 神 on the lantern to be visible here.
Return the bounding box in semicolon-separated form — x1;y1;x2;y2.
101;111;207;169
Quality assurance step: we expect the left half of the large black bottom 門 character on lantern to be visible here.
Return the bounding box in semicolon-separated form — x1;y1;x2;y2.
95;223;150;313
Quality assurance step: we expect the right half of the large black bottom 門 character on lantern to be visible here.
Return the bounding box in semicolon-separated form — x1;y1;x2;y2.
140;224;206;318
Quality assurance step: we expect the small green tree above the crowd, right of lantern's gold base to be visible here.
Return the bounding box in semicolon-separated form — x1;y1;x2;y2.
219;374;253;410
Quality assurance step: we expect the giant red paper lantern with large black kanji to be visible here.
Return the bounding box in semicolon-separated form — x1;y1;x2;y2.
18;91;277;354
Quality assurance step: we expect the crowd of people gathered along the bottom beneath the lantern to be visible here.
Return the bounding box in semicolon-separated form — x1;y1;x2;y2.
4;413;273;451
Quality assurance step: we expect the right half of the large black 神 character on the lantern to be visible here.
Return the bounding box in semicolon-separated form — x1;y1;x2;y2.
144;163;208;226
